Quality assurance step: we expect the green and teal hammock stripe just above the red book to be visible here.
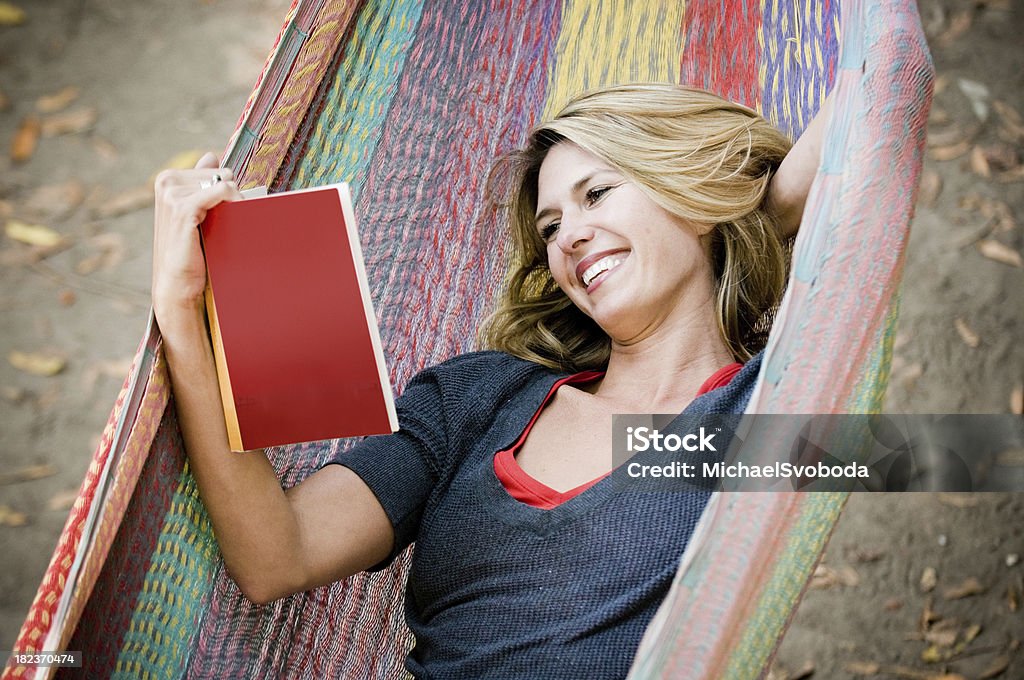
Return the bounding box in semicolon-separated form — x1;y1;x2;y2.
293;0;429;202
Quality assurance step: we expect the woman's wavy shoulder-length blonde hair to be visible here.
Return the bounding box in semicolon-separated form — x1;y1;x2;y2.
480;84;791;372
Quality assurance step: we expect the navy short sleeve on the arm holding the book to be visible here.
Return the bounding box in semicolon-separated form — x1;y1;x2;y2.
319;371;447;570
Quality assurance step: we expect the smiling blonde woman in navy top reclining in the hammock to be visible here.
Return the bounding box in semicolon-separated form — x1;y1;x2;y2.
153;85;821;678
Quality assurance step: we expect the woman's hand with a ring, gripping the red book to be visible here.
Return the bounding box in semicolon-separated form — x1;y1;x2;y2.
153;154;242;323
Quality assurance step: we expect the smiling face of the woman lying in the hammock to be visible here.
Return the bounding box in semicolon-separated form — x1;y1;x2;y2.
536;142;714;344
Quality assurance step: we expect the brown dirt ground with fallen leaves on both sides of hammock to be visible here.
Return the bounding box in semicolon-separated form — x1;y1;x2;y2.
0;0;1024;680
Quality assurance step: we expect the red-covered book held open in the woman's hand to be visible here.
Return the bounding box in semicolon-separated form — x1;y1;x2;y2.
201;184;398;451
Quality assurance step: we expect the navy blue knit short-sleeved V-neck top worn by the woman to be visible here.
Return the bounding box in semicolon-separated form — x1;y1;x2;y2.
331;352;760;679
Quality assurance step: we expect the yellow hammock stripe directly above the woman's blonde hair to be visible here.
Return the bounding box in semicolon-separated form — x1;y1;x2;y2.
544;0;685;120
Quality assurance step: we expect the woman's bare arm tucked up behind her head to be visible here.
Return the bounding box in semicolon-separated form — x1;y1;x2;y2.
765;94;833;239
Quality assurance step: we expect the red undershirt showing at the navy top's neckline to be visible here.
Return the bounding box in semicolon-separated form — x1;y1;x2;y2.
495;364;743;510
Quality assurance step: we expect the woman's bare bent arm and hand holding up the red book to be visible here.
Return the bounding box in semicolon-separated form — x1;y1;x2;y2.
153;155;394;603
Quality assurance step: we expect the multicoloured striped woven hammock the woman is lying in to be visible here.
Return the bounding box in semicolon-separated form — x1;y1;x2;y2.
3;0;933;678
